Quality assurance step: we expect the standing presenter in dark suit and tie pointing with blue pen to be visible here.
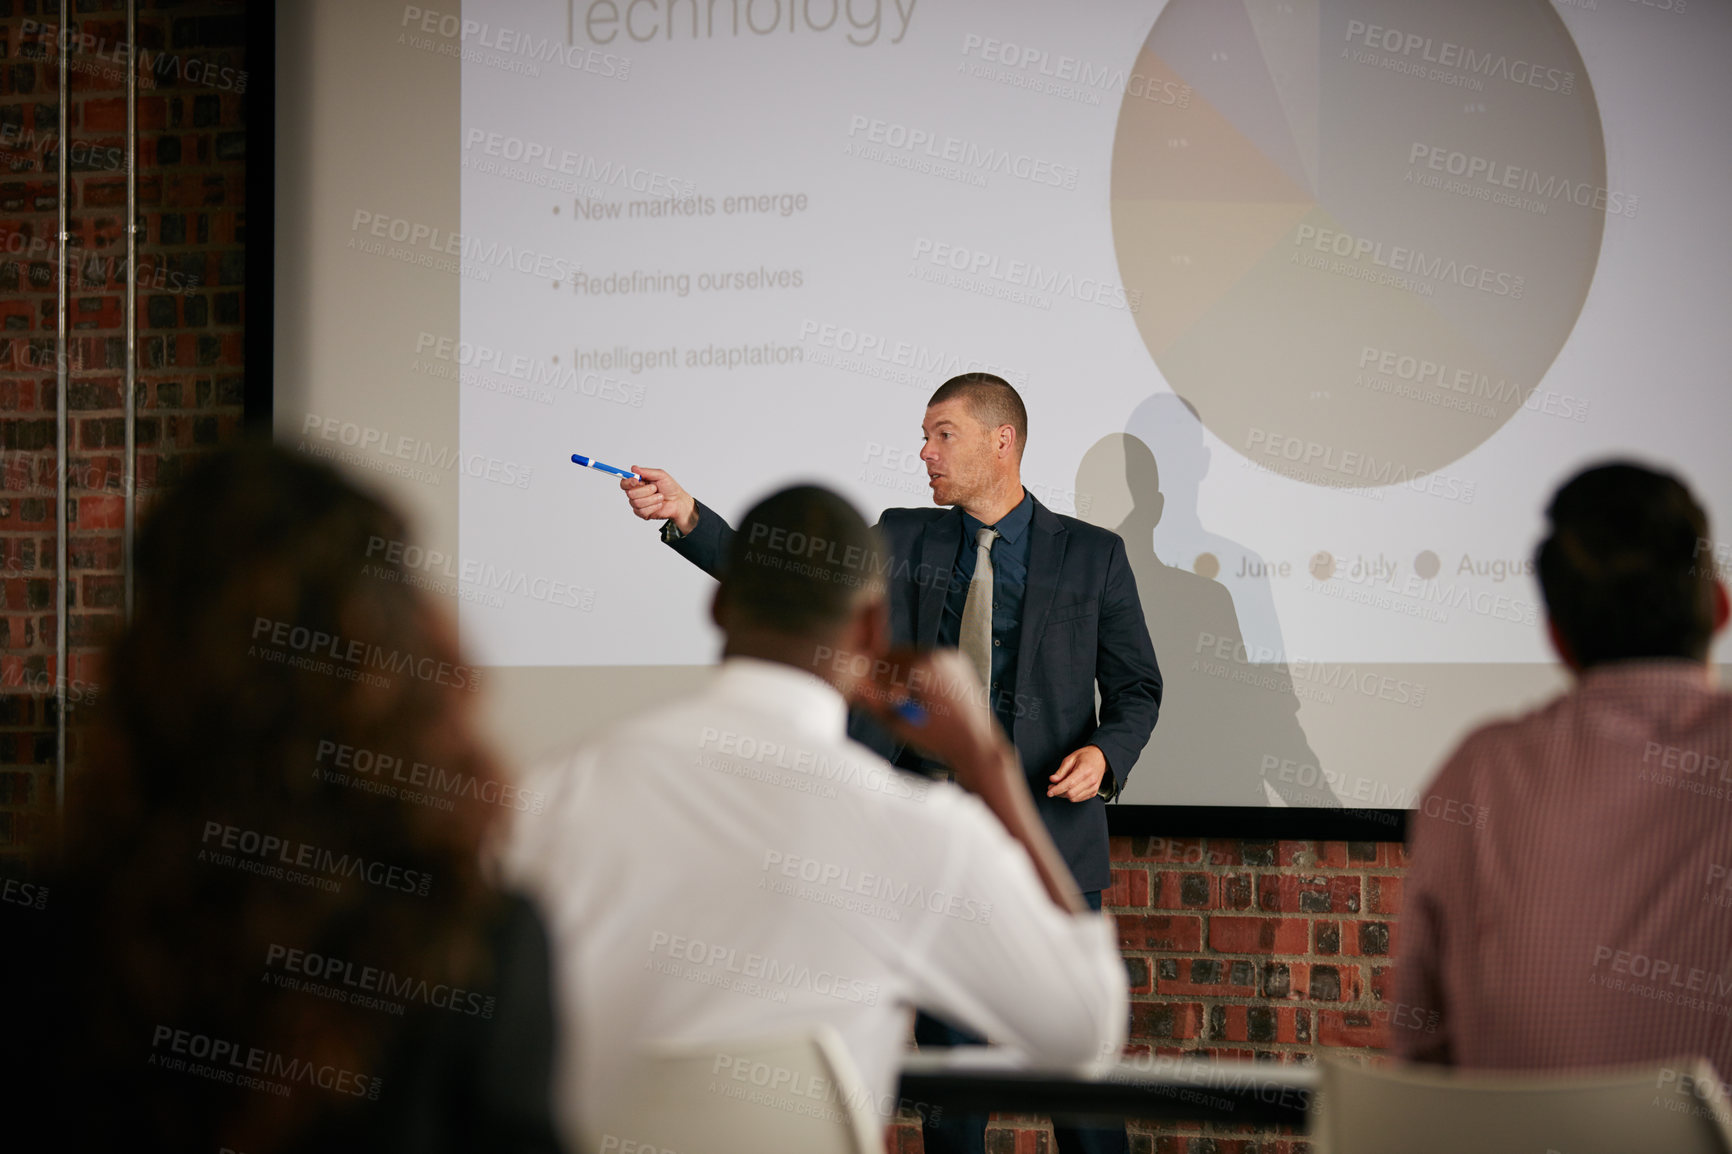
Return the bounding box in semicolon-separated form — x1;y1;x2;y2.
620;373;1160;1151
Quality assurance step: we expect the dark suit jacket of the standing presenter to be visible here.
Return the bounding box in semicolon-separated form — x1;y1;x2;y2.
670;488;1160;891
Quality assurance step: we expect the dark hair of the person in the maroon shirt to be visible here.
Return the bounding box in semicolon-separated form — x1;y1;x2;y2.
1535;461;1715;669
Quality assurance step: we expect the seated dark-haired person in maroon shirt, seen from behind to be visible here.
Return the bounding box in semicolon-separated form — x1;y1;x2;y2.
1389;463;1732;1078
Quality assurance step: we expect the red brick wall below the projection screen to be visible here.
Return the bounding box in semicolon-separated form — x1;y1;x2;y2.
895;837;1406;1154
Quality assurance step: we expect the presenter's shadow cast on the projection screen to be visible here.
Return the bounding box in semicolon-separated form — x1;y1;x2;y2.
1076;395;1341;807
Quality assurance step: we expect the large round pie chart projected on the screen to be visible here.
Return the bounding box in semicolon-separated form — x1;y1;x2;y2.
1112;0;1600;487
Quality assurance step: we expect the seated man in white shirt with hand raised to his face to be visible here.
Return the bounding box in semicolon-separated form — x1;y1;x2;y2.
507;487;1128;1149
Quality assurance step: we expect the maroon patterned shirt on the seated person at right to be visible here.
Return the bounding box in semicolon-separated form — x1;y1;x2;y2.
1389;660;1732;1078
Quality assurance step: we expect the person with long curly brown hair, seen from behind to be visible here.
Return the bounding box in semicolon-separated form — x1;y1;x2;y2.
12;445;558;1154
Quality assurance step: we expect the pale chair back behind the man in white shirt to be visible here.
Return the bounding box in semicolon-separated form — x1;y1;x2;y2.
584;1026;889;1154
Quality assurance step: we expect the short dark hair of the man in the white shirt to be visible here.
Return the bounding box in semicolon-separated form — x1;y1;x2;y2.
721;485;889;636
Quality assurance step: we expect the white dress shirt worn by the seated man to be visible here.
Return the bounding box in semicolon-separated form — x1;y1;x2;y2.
507;657;1128;1137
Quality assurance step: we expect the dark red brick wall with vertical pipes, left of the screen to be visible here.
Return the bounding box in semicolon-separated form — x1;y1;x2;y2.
0;0;246;859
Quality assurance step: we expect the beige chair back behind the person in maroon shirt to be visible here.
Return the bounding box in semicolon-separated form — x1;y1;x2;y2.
1308;1055;1732;1154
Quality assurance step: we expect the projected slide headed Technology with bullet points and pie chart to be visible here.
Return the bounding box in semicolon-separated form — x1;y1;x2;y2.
446;0;1732;807
